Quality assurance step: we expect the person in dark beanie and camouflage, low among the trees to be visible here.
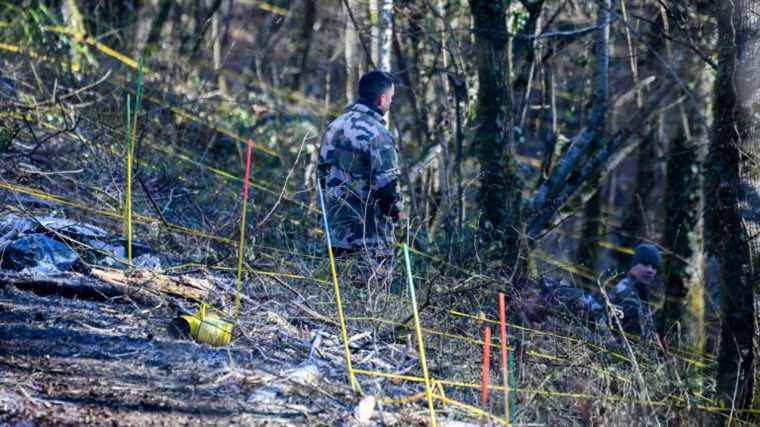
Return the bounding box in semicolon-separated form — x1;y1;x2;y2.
610;244;661;338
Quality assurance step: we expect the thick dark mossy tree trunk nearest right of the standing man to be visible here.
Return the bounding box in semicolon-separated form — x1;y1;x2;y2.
470;0;522;267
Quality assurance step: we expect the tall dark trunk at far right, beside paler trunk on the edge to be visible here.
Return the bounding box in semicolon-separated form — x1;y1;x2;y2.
705;1;760;408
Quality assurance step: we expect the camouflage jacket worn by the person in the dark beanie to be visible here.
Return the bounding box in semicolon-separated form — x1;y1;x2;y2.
610;276;654;338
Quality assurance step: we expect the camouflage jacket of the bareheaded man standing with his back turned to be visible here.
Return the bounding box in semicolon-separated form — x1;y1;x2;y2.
317;103;401;255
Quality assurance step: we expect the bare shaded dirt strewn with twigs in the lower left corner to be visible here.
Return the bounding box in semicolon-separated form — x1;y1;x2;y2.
0;286;360;425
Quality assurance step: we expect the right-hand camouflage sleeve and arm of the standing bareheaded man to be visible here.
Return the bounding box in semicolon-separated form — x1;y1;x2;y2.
370;134;402;220
